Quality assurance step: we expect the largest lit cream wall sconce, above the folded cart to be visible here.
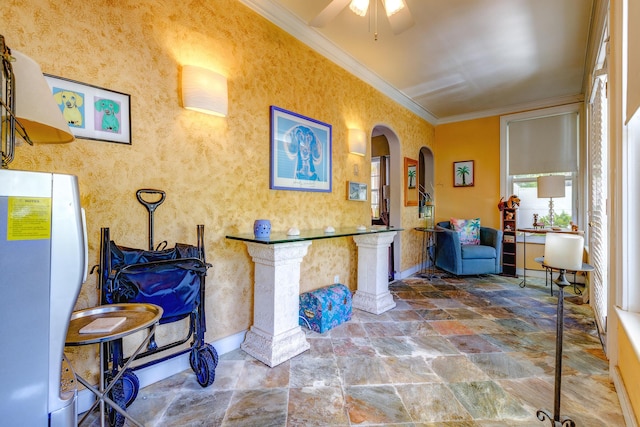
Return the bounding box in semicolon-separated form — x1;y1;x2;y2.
182;65;228;117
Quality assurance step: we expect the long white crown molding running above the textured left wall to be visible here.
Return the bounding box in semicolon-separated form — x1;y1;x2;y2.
239;0;438;125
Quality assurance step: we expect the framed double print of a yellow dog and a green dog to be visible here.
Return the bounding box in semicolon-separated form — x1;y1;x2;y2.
44;74;131;144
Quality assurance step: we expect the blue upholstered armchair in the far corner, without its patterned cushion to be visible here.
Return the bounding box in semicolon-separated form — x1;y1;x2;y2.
435;221;502;276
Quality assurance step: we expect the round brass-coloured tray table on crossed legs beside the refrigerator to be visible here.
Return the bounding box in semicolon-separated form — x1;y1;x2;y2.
66;304;162;427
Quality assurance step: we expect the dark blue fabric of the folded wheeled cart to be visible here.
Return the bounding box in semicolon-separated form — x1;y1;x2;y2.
106;242;207;323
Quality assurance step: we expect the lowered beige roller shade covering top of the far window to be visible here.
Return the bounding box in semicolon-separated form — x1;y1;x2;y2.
507;112;578;175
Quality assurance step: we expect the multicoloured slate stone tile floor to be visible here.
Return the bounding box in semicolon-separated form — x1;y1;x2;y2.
84;276;625;427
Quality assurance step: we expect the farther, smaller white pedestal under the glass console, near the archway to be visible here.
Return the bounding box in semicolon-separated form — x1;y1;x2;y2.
353;231;396;314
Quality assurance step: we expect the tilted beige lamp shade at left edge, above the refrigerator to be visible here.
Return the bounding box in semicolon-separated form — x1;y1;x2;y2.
11;50;74;143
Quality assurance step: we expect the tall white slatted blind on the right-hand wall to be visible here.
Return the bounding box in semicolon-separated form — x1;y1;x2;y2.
589;79;608;340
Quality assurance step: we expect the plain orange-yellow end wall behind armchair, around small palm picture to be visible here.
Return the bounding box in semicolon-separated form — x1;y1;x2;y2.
435;116;500;231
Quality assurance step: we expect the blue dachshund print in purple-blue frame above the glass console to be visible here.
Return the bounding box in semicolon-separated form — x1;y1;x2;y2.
269;106;332;193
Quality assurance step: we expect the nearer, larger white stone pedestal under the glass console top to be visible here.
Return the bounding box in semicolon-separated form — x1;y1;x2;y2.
240;241;311;367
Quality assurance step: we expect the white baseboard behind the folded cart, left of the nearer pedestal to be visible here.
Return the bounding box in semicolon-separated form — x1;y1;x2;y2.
78;331;247;414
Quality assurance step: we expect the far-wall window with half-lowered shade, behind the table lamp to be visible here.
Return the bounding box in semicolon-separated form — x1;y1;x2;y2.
500;104;584;229
